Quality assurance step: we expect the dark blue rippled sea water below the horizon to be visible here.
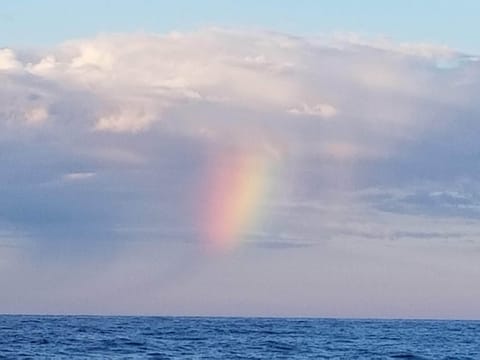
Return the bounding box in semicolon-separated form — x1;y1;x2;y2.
0;316;480;359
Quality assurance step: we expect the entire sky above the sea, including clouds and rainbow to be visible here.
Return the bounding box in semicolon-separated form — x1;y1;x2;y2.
0;0;480;319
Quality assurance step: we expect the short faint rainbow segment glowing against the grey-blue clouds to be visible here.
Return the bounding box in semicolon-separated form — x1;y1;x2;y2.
199;151;275;251
